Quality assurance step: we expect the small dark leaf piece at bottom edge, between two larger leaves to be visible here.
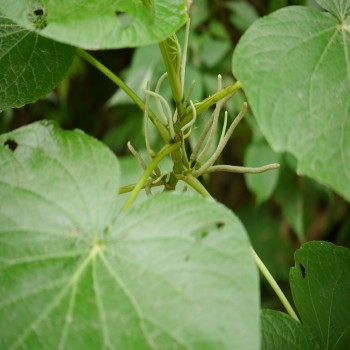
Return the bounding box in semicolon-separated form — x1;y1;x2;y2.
261;310;318;350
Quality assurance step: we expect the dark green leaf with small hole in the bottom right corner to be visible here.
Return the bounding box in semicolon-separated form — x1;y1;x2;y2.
290;241;350;350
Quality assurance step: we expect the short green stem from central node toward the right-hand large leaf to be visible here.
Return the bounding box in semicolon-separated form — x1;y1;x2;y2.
181;81;242;128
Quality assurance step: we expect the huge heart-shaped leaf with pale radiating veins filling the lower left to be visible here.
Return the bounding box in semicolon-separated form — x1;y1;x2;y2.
0;122;259;350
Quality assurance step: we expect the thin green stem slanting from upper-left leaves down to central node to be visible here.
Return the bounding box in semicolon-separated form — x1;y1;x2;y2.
77;48;170;143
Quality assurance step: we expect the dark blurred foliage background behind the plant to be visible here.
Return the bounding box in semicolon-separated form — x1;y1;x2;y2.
0;0;350;309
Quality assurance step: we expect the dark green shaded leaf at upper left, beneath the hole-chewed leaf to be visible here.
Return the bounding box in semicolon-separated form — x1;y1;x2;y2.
0;13;75;109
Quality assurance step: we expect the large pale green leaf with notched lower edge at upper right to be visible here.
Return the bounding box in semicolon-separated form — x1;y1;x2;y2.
233;0;350;200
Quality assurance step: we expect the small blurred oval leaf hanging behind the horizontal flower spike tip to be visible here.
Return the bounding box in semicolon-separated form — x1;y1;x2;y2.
244;141;279;204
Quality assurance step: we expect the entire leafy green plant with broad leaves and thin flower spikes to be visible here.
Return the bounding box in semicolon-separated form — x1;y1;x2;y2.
0;0;350;350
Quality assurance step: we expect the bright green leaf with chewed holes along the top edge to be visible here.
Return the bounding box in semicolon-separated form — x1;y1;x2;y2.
0;0;187;49
